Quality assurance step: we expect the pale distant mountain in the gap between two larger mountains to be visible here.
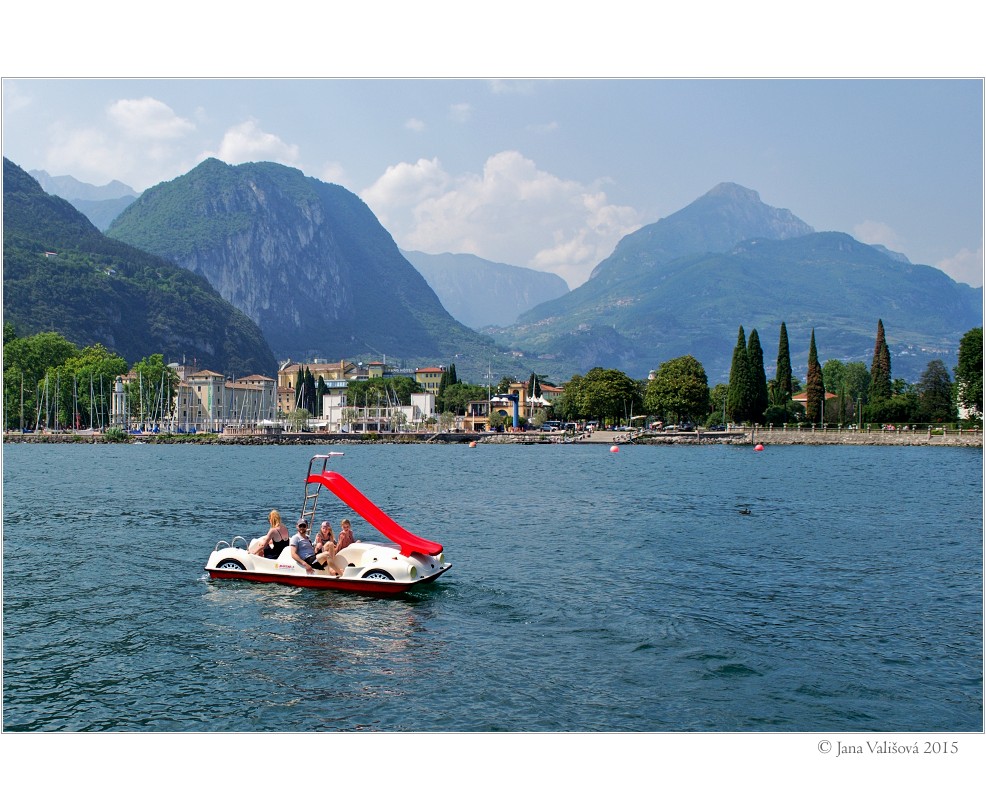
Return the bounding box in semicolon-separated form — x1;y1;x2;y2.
401;251;568;329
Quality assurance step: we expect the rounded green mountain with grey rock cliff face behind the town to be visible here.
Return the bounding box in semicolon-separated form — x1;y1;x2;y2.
109;159;493;368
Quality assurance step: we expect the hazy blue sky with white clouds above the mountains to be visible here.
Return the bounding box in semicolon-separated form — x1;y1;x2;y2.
3;74;983;288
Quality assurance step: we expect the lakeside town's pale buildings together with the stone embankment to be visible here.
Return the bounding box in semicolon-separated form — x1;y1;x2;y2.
4;360;982;447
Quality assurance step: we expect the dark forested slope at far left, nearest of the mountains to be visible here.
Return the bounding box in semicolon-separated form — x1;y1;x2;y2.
3;158;277;375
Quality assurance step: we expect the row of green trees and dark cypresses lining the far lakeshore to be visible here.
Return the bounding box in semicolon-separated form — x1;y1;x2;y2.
4;320;983;440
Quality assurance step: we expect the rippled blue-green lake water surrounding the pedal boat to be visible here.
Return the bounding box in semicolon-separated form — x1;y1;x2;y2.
3;445;983;732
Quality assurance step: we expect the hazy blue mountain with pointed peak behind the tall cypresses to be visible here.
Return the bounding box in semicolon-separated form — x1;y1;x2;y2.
490;184;983;383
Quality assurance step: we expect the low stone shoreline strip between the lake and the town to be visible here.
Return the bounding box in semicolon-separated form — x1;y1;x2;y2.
3;428;983;448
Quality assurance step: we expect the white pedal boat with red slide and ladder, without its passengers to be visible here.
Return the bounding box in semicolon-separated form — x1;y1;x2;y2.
205;453;452;595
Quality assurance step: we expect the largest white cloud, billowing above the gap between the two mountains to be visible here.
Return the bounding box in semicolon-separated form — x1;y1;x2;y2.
361;151;640;287
